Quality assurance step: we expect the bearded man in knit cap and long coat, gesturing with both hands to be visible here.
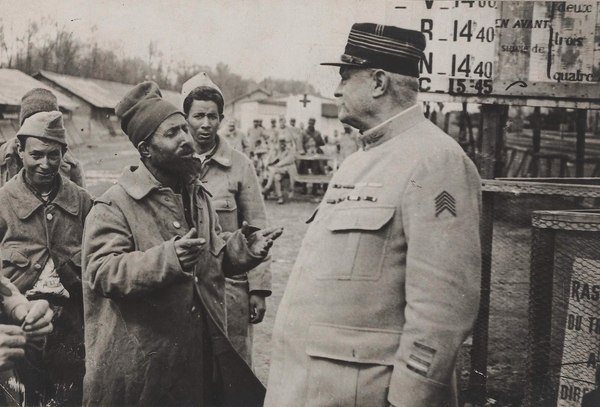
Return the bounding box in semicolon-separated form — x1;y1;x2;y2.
83;82;281;406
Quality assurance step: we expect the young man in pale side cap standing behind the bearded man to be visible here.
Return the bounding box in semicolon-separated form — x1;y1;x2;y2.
181;72;271;365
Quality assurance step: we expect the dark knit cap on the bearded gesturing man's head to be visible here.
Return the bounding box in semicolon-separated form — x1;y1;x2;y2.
115;81;183;147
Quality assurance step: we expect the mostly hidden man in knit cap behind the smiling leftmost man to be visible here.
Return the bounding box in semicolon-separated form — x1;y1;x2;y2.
0;88;85;188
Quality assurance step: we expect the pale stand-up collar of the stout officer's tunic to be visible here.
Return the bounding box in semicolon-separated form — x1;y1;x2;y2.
358;104;426;151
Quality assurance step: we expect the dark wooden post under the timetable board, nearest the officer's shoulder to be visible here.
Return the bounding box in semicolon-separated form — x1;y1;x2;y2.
479;104;508;179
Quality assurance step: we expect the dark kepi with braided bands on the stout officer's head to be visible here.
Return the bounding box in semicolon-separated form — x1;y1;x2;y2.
321;23;425;78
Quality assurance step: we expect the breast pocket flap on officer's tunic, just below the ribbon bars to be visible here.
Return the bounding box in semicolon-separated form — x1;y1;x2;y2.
328;206;396;232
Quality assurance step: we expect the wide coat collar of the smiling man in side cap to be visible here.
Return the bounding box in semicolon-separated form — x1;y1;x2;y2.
4;169;79;219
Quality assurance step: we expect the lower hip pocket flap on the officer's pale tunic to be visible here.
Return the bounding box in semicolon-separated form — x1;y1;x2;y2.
306;324;402;366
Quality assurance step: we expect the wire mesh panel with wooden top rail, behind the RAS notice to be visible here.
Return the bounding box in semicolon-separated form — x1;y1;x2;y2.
462;179;600;406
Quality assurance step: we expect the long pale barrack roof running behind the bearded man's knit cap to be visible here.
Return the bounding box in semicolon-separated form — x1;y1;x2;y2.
36;71;180;109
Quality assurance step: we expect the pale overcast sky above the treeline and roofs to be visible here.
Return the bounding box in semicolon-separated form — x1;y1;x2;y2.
0;0;386;96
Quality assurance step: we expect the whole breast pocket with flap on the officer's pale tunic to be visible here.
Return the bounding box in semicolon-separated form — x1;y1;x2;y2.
317;206;395;280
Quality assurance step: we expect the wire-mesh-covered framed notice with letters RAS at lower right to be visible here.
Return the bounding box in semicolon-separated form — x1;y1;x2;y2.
524;211;600;407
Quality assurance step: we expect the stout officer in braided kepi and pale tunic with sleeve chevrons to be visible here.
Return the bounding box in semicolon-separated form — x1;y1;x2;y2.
265;23;480;407
